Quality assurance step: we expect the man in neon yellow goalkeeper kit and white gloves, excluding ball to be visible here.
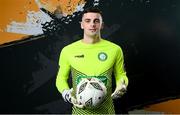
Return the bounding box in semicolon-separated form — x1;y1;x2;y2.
56;8;128;114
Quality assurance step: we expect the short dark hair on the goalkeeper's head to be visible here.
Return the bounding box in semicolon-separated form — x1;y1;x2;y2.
81;7;102;18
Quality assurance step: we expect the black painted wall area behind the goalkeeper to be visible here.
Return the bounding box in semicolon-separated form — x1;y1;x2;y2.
0;0;180;113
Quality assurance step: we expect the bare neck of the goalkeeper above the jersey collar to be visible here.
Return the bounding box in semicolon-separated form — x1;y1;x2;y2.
82;35;101;44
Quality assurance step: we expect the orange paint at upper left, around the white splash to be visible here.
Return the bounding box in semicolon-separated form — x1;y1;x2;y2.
0;0;85;44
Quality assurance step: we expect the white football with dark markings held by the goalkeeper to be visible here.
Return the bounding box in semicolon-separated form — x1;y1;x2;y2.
76;78;107;108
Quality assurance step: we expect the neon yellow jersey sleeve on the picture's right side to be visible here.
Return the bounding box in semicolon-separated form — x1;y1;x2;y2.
114;48;129;86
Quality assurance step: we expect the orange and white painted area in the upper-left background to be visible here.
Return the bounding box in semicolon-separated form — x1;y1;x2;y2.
0;0;99;44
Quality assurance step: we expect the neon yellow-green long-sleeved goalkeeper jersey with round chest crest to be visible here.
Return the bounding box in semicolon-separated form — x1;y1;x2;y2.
56;39;128;114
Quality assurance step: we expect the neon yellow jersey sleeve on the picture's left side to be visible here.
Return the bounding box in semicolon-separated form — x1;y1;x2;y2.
56;49;70;93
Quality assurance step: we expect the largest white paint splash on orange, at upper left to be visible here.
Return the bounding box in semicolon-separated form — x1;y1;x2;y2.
6;11;52;35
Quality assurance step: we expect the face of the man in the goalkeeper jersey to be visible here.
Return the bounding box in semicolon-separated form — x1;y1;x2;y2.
81;12;102;37
